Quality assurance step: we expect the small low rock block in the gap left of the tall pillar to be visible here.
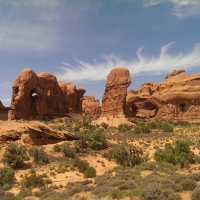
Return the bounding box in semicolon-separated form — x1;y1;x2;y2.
82;96;101;118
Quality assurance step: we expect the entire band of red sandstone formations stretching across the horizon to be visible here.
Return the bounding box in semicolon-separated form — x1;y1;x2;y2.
5;67;200;122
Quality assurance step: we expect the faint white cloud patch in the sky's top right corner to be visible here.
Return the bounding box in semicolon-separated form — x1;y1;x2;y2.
143;0;200;18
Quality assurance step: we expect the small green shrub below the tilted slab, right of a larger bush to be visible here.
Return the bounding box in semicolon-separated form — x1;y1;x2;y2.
29;146;49;165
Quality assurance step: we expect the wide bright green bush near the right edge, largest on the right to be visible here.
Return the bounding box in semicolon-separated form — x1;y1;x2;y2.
154;140;195;168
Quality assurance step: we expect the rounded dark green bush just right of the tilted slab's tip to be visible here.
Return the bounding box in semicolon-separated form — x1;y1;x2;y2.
88;131;108;150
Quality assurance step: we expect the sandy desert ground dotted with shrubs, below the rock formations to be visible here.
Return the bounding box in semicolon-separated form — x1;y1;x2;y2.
0;115;200;200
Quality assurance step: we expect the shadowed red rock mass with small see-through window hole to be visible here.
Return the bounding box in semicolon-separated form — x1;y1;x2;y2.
9;68;85;119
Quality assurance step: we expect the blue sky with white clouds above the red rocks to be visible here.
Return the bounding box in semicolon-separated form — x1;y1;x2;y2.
0;0;200;106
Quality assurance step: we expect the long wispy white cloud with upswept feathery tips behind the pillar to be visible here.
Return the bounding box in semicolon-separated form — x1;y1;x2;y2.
56;43;200;81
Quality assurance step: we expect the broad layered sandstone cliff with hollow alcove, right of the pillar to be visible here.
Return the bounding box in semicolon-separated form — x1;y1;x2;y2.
125;70;200;120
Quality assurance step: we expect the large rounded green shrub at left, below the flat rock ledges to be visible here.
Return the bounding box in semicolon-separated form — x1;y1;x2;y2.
1;142;29;168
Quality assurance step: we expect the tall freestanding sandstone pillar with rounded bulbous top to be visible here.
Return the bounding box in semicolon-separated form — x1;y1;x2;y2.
101;67;131;118
